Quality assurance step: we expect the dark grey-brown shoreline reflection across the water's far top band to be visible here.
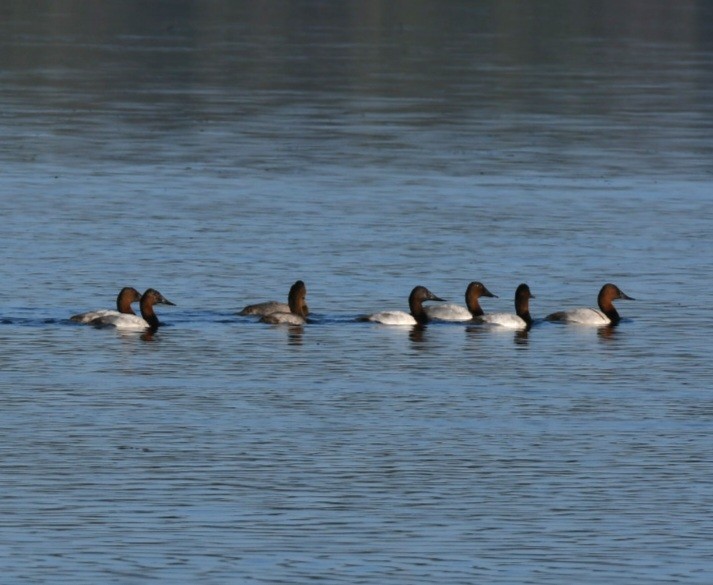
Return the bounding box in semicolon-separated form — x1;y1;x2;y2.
0;1;713;177
